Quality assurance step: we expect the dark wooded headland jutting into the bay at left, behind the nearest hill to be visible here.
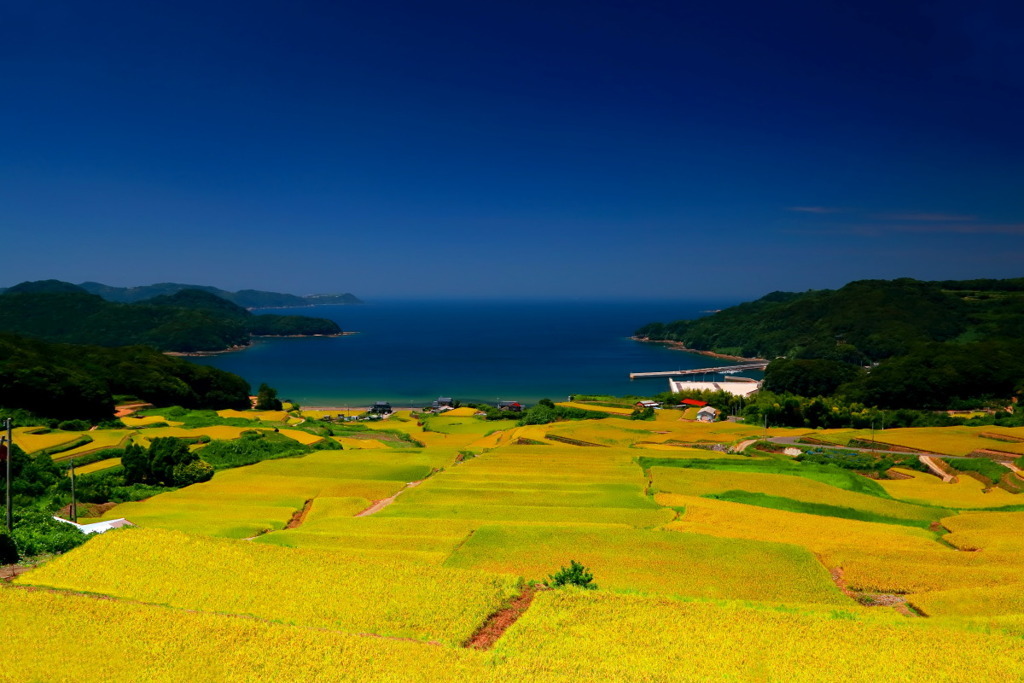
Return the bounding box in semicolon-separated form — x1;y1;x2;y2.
0;280;343;353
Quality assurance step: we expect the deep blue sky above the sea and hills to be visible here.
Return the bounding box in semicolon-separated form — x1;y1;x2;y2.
0;0;1024;300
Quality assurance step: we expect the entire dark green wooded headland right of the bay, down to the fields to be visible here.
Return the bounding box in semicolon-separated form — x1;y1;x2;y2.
635;279;1024;409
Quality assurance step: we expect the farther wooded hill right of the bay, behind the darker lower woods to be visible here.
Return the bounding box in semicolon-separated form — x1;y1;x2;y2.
635;279;1024;364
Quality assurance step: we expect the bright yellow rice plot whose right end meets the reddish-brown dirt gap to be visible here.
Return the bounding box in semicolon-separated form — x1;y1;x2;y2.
17;529;519;645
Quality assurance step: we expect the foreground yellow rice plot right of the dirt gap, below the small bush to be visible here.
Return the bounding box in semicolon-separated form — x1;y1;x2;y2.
489;591;1024;681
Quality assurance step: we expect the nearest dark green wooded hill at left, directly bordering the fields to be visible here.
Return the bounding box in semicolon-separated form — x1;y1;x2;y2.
0;333;249;421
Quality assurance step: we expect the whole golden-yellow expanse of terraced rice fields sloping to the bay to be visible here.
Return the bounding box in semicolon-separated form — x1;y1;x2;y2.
12;411;1024;683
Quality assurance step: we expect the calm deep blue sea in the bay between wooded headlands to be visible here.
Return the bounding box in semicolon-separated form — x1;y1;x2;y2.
188;301;749;405
